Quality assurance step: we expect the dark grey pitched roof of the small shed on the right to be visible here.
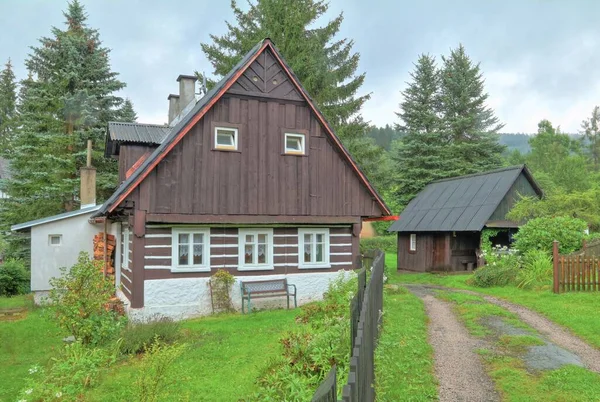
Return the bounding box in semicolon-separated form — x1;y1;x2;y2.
389;165;542;232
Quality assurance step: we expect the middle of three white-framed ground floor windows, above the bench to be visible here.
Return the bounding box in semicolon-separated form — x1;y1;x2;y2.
238;229;273;270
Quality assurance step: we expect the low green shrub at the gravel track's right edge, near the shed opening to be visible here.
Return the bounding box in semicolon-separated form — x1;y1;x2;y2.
470;254;521;288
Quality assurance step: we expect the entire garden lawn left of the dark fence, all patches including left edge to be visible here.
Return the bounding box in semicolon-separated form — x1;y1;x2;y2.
0;296;300;402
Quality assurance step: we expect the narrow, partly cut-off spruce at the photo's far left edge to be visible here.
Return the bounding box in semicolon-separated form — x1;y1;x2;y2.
0;59;17;152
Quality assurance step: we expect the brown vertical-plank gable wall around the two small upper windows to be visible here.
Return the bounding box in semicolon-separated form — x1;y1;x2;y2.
130;96;381;216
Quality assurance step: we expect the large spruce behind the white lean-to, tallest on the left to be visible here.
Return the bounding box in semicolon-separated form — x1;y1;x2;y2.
3;0;125;223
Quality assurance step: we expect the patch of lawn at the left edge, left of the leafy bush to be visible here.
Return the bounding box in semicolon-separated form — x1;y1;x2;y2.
0;296;62;402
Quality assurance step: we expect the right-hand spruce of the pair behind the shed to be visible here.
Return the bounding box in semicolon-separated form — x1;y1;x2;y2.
440;45;504;174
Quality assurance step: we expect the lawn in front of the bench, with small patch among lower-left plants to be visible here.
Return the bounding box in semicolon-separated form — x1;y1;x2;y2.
86;310;299;401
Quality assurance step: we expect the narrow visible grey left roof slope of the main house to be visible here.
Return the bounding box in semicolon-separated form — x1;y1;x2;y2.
93;41;264;216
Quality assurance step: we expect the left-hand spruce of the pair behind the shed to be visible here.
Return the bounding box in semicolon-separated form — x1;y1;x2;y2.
391;55;456;209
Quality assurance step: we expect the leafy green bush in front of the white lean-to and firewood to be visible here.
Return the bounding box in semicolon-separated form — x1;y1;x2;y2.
50;253;126;345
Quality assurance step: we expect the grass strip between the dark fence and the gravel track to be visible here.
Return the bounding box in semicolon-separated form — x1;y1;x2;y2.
375;287;437;402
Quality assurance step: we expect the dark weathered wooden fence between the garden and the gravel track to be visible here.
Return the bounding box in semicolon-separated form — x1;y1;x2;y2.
312;251;385;402
